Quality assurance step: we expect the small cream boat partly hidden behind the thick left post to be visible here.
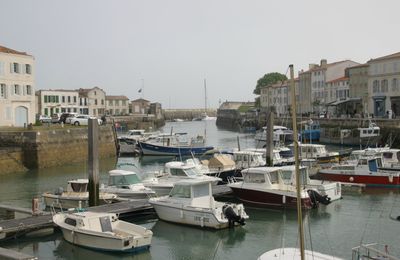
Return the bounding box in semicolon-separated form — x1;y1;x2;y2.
42;179;117;209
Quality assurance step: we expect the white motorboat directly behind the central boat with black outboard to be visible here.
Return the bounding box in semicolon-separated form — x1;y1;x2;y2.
142;161;221;196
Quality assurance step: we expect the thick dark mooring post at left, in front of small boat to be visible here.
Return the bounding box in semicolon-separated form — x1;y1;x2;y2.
88;119;99;207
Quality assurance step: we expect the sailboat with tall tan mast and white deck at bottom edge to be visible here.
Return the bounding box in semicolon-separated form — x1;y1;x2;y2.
258;65;341;260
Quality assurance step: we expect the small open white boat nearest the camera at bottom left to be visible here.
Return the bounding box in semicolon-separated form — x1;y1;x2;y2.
53;211;153;252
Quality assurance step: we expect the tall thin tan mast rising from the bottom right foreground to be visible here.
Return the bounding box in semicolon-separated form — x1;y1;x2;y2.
289;64;305;260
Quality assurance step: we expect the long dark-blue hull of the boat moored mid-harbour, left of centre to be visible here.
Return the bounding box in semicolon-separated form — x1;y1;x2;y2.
139;142;214;156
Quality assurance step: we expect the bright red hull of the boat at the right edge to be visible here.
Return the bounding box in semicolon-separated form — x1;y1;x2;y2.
317;170;400;187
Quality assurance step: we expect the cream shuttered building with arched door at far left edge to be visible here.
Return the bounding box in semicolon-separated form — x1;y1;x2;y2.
0;46;35;126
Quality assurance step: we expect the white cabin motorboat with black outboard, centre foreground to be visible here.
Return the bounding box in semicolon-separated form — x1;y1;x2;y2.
149;180;248;229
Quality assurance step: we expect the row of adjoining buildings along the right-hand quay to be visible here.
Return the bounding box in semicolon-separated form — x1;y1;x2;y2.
260;55;400;117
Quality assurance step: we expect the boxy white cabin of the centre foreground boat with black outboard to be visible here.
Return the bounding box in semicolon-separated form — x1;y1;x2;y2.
169;180;214;208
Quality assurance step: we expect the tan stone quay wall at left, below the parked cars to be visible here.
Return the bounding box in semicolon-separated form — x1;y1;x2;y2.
0;125;117;170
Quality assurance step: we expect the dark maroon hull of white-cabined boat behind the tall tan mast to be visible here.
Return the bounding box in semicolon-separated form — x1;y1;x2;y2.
230;186;312;209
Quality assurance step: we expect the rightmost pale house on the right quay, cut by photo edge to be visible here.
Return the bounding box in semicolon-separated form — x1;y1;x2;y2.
367;52;400;117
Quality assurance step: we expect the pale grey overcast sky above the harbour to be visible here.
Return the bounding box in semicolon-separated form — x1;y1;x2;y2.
0;0;400;108
